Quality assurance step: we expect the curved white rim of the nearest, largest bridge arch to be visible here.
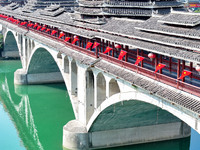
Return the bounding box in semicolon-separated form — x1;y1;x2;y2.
87;91;200;133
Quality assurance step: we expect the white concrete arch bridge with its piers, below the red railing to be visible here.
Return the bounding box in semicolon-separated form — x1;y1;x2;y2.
1;22;200;149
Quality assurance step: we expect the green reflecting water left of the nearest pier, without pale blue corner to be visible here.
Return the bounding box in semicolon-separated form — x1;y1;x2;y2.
0;61;74;150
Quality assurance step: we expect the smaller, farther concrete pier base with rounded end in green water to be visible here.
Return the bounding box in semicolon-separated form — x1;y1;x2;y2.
14;69;64;84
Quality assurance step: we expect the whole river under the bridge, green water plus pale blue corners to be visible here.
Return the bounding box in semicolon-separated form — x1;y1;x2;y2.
0;60;200;150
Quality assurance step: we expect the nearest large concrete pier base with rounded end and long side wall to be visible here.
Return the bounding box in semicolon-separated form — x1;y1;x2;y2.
63;120;191;150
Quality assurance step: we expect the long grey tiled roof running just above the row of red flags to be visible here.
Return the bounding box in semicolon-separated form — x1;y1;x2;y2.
0;4;200;62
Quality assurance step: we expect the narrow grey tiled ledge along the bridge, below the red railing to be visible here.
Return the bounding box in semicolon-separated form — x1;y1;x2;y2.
0;21;200;114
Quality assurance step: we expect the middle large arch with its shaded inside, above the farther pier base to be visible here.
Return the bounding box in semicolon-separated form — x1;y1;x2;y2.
25;44;64;84
